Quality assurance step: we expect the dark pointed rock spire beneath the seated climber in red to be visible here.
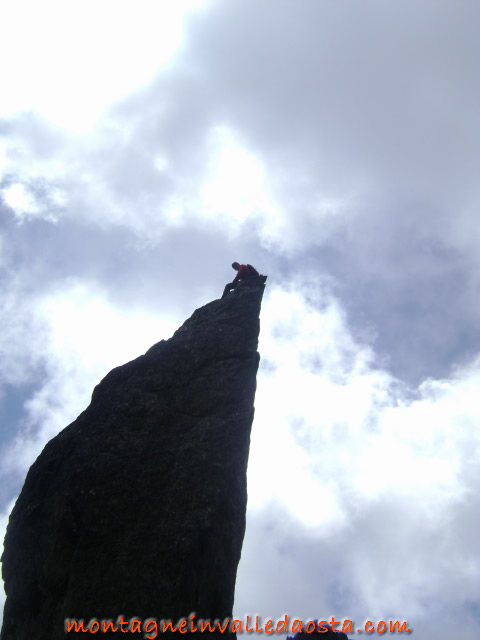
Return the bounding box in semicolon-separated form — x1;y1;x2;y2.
0;279;264;640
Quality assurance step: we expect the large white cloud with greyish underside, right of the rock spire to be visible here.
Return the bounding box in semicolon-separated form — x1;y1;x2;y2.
237;281;480;631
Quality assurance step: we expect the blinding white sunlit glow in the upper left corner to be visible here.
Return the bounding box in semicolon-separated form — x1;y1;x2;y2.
0;0;206;130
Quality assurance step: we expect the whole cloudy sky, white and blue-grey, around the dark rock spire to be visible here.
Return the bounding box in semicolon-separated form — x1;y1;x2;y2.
0;0;480;640
